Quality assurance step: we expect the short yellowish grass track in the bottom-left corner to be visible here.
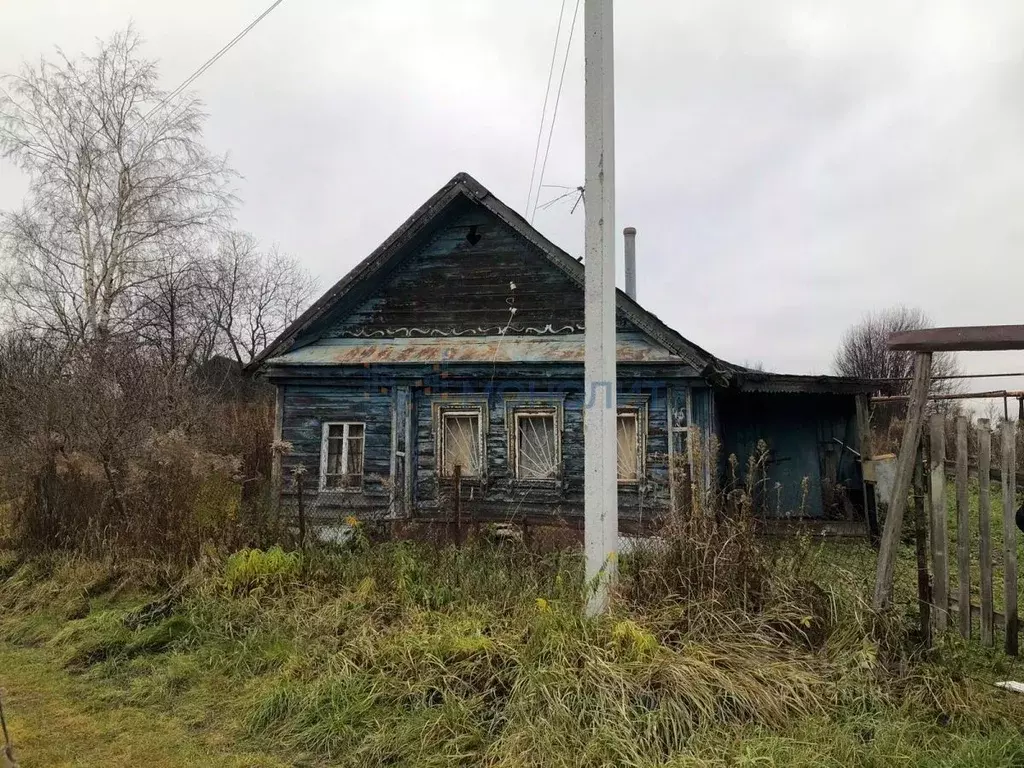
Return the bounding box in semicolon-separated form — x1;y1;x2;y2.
0;643;286;768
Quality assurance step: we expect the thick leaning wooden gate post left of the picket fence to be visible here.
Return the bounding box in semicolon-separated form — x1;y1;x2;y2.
873;352;932;610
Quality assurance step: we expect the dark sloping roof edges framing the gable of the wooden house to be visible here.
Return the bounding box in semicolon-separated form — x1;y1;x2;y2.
249;173;730;379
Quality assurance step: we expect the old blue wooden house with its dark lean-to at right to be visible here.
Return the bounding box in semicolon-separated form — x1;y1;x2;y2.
254;173;872;529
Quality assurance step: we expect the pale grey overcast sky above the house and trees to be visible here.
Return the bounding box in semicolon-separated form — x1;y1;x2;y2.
0;0;1024;389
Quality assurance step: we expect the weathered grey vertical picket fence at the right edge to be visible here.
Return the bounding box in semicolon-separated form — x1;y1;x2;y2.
912;414;1019;654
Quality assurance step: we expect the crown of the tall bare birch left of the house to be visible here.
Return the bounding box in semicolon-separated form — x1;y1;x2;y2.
0;29;232;340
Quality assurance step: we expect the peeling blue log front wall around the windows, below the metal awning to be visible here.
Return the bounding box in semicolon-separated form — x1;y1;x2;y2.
274;364;710;522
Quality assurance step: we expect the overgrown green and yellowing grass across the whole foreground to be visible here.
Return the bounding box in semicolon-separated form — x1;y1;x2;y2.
0;542;1024;768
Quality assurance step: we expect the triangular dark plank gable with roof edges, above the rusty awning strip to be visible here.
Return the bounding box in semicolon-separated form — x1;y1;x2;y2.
252;173;725;378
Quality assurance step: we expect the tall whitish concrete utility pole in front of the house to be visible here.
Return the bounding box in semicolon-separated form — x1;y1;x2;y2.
584;0;618;615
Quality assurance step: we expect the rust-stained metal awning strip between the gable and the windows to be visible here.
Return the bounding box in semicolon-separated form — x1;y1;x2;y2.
266;334;683;366
